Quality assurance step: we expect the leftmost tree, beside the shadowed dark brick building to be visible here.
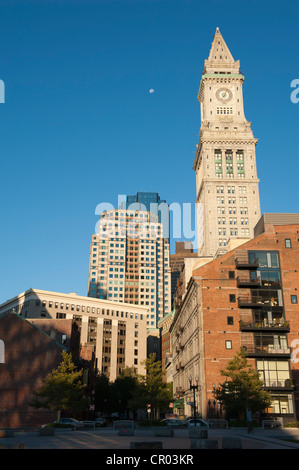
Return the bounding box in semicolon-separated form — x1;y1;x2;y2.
30;351;89;419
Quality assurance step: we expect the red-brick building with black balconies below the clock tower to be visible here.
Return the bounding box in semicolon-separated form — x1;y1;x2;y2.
170;214;299;422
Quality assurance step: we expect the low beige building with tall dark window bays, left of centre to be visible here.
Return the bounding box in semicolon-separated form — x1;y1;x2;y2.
0;289;148;381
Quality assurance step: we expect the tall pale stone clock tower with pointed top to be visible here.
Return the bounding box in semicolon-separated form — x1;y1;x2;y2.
193;28;260;257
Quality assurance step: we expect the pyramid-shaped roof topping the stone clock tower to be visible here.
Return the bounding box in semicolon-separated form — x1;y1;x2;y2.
204;27;240;73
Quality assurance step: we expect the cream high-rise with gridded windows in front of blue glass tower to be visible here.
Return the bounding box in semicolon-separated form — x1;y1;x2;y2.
88;209;171;328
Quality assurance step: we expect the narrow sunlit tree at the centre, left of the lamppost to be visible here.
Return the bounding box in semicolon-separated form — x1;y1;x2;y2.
130;354;173;418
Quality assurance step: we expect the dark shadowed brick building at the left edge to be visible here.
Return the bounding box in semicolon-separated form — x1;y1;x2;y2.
0;312;66;427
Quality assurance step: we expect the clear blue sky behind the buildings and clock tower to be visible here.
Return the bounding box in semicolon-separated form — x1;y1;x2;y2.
0;0;299;303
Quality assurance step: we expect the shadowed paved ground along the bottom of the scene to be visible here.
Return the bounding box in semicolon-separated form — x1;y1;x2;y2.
0;427;299;452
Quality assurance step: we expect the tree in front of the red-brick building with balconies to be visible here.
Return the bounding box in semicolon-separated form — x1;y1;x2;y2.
213;348;272;417
